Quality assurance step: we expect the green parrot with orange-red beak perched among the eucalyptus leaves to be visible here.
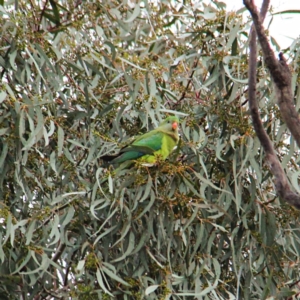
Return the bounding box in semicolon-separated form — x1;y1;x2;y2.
101;116;179;164
